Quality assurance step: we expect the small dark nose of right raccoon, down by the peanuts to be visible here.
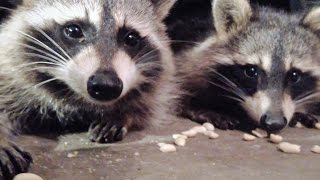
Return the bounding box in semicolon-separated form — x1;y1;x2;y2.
260;114;288;133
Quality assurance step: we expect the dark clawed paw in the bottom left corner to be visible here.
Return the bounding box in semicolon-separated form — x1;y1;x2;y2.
0;144;32;179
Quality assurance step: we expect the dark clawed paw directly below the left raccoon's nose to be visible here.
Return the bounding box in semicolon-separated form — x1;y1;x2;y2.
89;121;128;143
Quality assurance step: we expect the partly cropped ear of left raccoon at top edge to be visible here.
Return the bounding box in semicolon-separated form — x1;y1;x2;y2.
151;0;177;20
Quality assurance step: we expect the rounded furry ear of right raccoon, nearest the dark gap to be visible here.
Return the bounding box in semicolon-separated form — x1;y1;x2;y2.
212;0;252;36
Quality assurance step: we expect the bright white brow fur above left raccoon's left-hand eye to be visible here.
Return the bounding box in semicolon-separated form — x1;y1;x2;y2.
25;0;104;29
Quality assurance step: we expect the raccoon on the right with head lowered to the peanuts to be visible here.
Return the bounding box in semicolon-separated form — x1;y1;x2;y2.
177;0;320;132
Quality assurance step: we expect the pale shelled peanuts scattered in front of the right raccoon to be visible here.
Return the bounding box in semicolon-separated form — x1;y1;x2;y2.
158;123;320;154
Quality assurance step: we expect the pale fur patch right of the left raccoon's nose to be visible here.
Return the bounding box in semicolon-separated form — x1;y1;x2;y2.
112;51;140;97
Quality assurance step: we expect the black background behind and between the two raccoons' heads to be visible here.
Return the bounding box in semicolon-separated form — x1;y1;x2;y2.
0;0;320;53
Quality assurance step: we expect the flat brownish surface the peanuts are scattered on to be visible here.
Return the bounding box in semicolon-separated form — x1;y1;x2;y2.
19;121;320;180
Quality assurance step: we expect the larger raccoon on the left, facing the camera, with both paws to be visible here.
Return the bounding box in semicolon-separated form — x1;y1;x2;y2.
0;0;175;177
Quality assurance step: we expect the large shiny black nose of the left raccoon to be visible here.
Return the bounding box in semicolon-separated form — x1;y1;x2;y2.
87;71;123;101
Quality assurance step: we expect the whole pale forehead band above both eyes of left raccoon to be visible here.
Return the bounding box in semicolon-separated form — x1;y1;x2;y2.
24;0;158;36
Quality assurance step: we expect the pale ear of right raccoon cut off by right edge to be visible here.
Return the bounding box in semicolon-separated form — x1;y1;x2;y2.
302;7;320;36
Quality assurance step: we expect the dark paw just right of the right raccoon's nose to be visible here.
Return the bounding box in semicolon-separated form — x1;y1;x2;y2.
289;113;319;128
